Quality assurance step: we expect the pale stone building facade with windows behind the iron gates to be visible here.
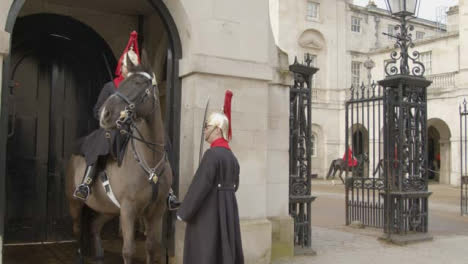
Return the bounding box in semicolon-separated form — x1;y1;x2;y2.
270;0;467;185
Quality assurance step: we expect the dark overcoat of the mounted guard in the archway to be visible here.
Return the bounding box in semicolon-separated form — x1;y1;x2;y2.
78;82;128;166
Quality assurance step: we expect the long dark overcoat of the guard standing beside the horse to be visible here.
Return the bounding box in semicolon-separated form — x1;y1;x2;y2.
177;147;244;264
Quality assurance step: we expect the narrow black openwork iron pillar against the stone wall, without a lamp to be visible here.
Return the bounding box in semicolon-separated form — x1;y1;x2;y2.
289;54;318;248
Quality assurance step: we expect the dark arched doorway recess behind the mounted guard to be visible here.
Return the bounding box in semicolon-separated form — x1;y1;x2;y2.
5;14;115;243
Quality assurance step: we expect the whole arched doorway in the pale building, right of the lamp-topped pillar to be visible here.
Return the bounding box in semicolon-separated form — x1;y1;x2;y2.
427;118;451;184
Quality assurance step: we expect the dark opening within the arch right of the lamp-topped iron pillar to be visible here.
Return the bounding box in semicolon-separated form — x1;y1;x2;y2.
427;126;440;181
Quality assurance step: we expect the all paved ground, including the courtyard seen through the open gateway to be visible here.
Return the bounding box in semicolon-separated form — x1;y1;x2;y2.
274;180;468;264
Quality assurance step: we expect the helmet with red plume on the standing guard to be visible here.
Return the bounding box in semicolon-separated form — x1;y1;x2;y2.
206;90;232;141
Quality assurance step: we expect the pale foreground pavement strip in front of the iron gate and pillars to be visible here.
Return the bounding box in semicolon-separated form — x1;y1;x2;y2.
273;226;468;264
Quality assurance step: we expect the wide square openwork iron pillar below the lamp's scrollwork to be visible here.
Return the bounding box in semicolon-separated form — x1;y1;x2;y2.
379;72;431;240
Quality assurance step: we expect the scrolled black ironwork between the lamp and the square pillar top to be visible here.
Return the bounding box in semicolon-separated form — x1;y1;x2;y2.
383;16;426;77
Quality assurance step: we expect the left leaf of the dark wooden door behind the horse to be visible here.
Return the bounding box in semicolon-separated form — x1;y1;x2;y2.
5;52;51;242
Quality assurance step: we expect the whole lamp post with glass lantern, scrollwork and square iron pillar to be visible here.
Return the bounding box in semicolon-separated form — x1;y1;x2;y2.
378;0;432;244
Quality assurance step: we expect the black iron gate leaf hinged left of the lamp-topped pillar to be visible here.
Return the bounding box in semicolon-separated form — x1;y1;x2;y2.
344;83;384;228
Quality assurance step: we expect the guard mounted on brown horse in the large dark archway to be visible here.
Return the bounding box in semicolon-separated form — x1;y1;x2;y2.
66;32;178;264
